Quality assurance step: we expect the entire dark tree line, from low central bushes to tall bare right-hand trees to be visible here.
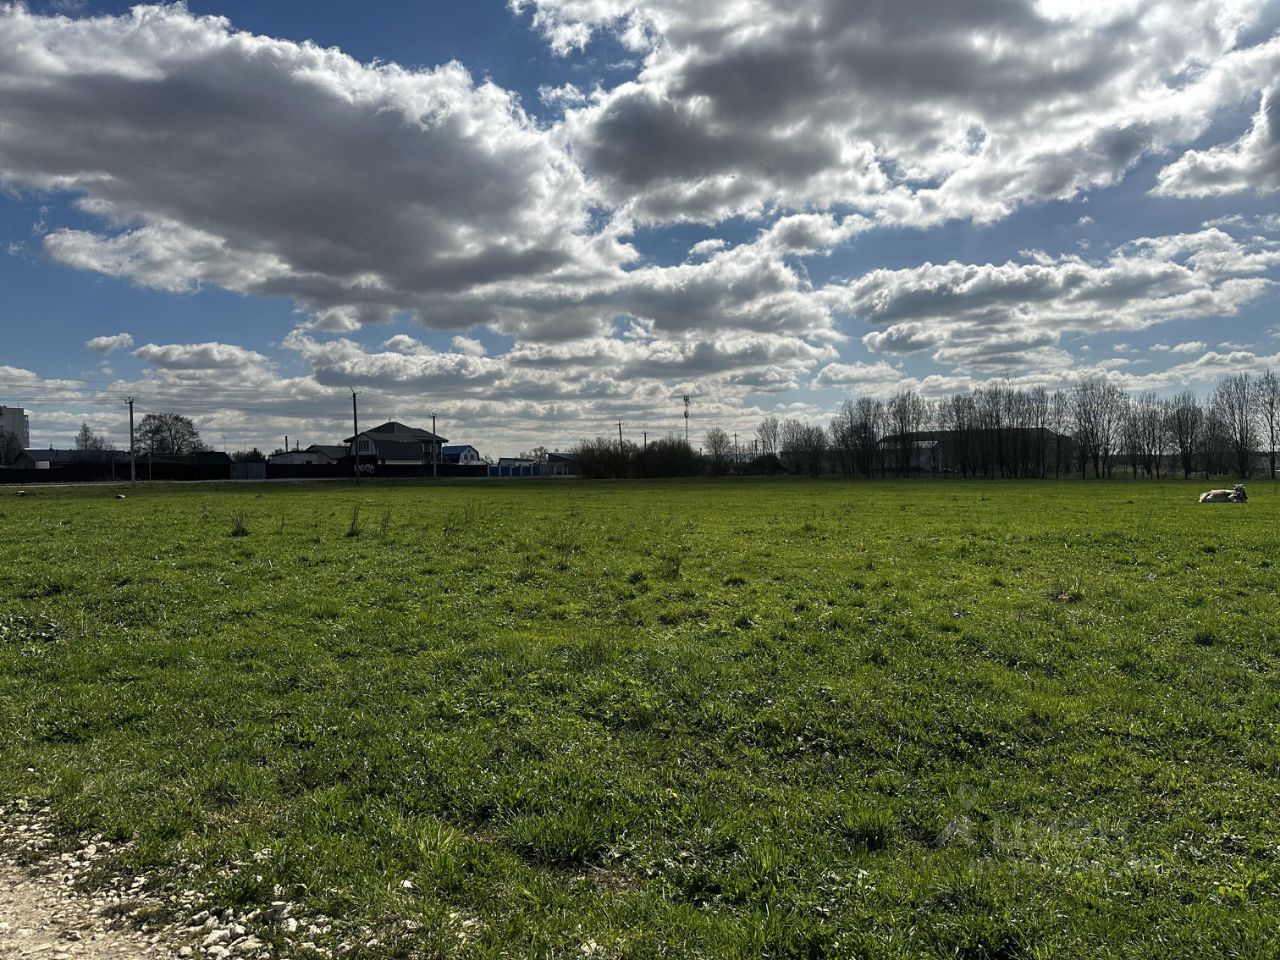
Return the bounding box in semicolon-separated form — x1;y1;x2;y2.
573;370;1280;479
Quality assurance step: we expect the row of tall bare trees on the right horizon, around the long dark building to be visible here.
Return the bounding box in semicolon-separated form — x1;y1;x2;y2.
814;370;1280;479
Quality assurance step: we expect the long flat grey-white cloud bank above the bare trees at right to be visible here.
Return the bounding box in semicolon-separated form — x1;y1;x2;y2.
822;229;1280;372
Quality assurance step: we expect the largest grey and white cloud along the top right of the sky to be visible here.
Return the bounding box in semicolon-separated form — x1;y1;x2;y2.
512;0;1280;224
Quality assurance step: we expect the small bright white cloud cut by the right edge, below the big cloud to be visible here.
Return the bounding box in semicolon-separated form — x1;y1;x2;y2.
1153;84;1280;197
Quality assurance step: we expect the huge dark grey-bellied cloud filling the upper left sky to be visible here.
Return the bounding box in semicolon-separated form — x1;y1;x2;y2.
0;5;630;326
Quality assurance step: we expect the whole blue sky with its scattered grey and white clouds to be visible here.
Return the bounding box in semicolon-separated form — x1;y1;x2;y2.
0;0;1280;457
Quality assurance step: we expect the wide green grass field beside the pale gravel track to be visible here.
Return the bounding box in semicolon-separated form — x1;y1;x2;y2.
0;481;1280;960
